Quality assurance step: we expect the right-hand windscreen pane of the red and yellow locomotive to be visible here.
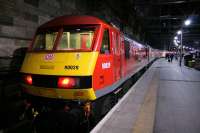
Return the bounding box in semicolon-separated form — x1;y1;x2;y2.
57;28;95;50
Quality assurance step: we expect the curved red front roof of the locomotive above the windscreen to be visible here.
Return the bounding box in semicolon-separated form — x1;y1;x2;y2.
39;15;108;28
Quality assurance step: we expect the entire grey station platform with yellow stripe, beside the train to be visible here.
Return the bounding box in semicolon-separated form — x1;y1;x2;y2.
91;59;200;133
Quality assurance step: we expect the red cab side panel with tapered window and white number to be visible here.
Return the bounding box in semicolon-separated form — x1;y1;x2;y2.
93;28;114;90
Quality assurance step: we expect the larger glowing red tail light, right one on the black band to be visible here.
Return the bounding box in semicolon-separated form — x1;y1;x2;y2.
58;77;76;89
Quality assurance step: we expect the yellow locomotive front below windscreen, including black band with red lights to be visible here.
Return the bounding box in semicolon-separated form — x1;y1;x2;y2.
21;52;97;100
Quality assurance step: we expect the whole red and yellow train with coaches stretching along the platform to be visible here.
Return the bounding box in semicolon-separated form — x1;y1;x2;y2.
20;16;160;131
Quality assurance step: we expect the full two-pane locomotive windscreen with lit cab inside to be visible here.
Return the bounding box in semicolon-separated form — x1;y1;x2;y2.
31;27;95;51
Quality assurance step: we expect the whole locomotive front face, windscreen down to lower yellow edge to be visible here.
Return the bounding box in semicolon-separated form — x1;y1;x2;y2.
21;26;98;100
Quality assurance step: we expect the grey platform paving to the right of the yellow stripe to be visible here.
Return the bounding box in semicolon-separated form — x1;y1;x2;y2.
154;60;200;133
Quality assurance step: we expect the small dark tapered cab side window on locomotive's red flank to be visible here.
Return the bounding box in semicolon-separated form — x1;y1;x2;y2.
100;29;110;54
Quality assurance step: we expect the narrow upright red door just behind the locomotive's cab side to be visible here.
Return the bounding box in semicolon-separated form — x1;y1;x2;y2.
111;30;122;80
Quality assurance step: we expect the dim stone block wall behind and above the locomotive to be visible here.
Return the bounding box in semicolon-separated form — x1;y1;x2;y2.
0;0;141;57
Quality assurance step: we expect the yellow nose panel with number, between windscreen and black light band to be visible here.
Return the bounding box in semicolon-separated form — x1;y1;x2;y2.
21;52;98;76
